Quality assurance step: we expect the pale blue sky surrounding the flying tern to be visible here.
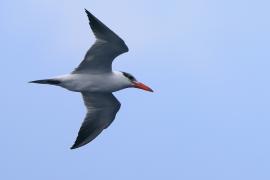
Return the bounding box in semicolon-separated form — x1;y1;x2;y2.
0;0;270;180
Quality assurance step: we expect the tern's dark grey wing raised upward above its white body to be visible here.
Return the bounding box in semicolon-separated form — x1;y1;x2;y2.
73;10;128;73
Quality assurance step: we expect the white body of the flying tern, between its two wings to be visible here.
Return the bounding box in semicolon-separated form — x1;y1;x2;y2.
57;72;128;92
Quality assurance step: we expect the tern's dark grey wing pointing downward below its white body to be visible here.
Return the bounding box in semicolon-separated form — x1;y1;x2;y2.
71;93;121;149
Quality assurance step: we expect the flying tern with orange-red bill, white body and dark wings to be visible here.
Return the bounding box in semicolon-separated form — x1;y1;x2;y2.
29;9;153;149
